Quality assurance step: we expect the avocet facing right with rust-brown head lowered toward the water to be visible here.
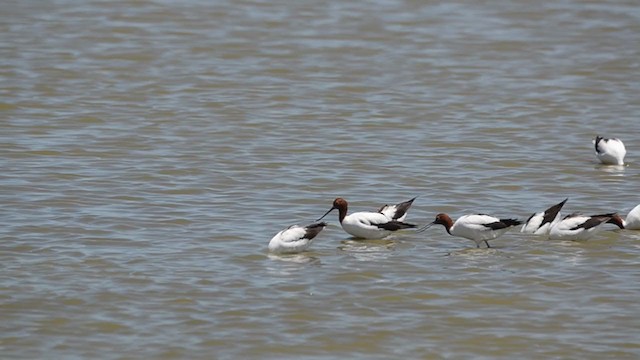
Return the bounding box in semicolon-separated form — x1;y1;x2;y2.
549;213;624;240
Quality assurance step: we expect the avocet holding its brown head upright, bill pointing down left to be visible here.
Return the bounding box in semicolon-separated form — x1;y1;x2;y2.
318;198;416;239
